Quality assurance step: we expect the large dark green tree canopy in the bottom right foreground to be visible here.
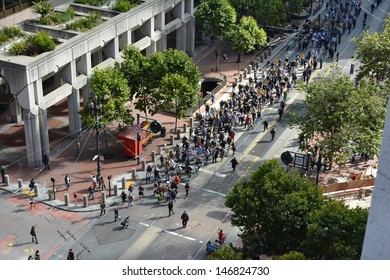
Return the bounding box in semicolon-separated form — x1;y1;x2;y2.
225;159;368;259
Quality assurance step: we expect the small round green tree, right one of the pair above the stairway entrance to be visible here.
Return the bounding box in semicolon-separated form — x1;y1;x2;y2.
229;16;267;74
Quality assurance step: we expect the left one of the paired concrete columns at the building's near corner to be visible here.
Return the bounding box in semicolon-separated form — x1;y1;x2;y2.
23;109;42;167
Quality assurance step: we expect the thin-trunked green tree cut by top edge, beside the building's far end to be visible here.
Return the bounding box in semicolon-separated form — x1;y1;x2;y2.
195;0;237;71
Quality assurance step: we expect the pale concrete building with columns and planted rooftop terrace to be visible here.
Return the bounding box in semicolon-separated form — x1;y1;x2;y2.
0;0;199;167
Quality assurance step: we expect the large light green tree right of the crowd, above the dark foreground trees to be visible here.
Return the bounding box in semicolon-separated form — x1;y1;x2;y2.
291;73;388;168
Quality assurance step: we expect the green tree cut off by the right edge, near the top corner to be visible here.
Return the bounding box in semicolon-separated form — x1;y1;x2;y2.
354;17;390;81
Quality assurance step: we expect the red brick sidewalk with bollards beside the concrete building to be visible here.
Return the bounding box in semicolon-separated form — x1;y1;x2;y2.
0;2;372;212
